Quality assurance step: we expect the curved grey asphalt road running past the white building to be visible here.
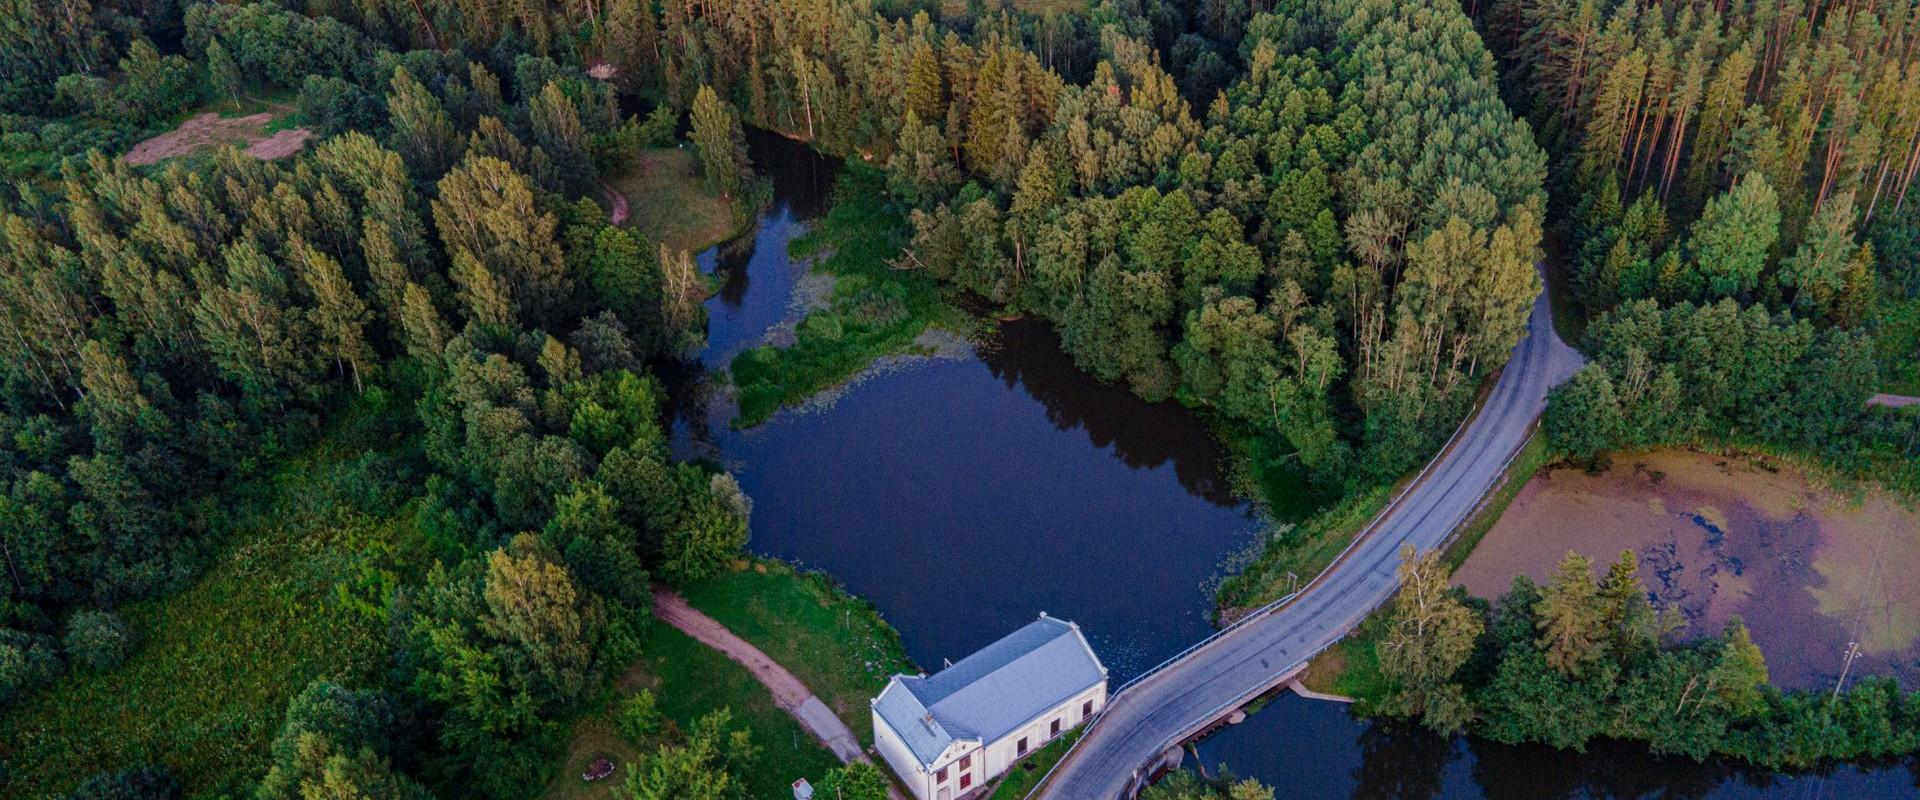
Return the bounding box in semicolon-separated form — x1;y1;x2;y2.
1035;292;1582;800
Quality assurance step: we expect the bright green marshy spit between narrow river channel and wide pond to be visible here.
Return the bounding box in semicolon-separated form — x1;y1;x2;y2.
730;165;968;428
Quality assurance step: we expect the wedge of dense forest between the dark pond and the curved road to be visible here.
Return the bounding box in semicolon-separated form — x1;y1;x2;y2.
652;2;1546;485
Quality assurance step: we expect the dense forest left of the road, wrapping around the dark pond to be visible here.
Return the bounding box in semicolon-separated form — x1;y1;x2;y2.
0;0;1546;796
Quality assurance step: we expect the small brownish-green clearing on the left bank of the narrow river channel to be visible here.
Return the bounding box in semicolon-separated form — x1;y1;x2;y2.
609;148;739;253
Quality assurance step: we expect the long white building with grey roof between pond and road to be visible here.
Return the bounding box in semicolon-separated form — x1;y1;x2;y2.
874;614;1106;800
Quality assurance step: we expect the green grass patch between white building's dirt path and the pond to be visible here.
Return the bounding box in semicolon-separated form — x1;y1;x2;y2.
684;560;914;744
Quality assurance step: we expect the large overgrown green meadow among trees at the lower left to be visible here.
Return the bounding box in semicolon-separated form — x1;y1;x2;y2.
0;402;424;798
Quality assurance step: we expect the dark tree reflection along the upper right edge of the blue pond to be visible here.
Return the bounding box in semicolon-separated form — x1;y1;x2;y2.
979;320;1240;506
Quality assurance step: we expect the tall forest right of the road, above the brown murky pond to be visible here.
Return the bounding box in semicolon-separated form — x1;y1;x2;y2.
1475;0;1920;473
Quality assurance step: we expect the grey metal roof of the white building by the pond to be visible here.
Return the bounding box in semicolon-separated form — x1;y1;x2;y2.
874;614;1106;765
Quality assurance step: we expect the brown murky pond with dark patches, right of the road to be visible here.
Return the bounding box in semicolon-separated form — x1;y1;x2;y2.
1453;451;1920;689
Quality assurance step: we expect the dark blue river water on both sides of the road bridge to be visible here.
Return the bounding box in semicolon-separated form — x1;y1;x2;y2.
674;132;1920;800
